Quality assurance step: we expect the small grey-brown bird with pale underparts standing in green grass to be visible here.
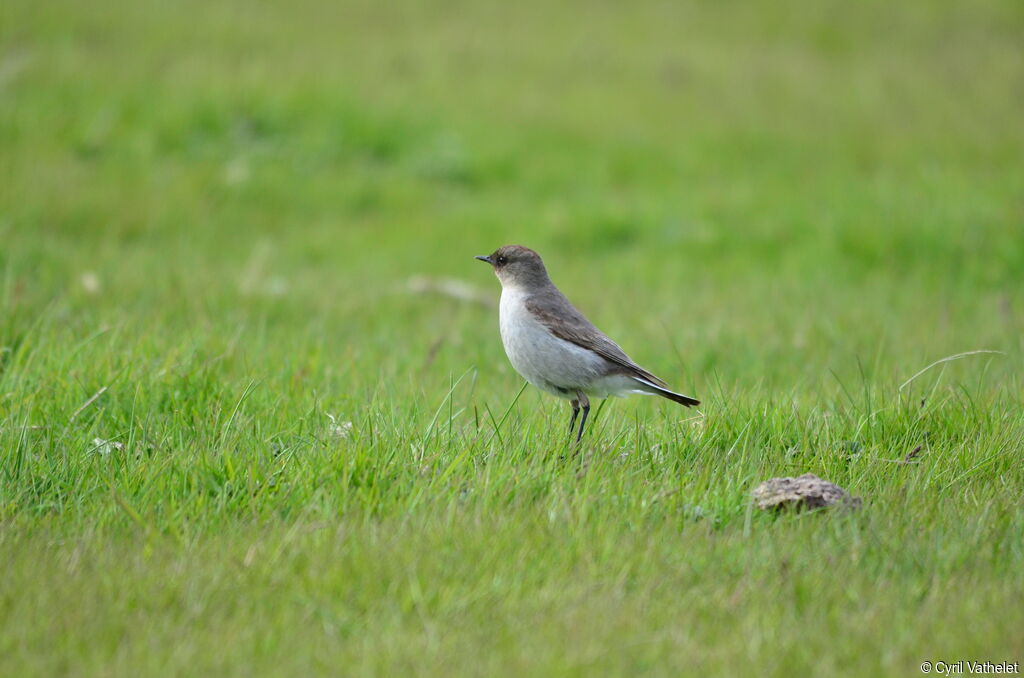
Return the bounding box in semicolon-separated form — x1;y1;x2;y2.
476;245;700;442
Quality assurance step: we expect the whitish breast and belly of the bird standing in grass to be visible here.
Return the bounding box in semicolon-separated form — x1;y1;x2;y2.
500;287;605;398
